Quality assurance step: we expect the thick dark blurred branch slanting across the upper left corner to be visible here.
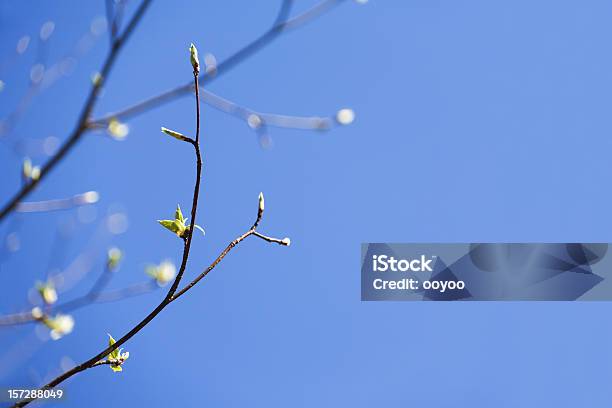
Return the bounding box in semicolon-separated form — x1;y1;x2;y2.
0;0;151;220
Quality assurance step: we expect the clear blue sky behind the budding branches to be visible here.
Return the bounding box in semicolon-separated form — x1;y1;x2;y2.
0;0;612;408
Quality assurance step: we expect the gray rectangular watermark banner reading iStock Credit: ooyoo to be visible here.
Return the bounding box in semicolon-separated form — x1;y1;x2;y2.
361;243;612;301
